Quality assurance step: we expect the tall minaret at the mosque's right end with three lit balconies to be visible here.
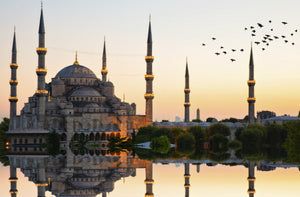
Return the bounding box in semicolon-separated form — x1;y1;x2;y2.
145;16;154;123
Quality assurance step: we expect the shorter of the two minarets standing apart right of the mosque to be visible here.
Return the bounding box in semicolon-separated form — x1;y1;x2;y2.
184;60;191;122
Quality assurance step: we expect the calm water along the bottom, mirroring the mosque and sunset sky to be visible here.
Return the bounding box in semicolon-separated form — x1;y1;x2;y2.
0;153;300;197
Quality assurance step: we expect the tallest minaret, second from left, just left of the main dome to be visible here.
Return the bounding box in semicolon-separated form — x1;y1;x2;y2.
36;7;48;128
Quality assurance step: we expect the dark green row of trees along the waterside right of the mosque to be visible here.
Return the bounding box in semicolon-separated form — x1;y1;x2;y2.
134;121;300;163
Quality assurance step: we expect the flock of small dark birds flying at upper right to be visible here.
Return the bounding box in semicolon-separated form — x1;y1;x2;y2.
202;20;300;62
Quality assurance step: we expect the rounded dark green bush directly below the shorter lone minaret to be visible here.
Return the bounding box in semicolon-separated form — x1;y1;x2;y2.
176;133;196;154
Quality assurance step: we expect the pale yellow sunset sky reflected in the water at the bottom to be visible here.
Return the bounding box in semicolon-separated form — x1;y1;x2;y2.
0;164;300;197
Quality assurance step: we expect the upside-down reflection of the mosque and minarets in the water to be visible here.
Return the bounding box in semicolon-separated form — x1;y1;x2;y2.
8;145;284;197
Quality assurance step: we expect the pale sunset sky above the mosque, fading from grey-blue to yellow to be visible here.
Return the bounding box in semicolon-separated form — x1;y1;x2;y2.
0;0;300;121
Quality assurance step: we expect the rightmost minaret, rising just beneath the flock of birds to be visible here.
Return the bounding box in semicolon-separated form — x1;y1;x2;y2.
247;45;256;124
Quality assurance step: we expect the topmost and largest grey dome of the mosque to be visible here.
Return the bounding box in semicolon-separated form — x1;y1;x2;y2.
55;64;97;79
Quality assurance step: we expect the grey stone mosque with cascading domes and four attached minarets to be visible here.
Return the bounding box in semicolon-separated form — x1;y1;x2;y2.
8;6;154;150
